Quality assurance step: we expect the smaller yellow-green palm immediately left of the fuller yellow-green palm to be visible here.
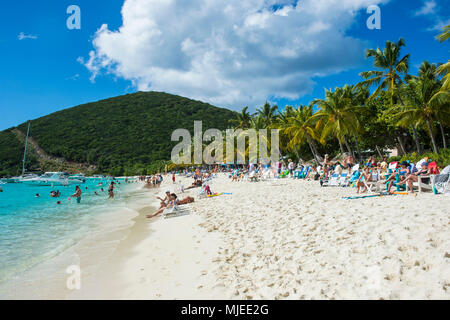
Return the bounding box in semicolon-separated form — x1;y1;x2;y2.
281;105;321;163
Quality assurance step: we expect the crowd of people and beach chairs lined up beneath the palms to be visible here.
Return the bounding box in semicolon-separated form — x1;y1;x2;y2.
222;154;450;195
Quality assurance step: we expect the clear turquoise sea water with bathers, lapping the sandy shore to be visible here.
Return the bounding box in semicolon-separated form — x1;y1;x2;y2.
0;179;137;284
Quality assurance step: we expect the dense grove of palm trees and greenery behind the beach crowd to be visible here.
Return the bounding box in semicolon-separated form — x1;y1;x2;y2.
231;26;450;165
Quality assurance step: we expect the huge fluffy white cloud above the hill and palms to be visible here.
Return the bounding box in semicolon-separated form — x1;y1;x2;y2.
79;0;386;108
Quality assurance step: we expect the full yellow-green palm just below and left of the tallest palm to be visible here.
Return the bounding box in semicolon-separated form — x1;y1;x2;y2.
310;88;361;155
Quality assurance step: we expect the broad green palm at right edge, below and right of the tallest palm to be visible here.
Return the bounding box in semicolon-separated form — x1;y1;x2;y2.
387;71;450;153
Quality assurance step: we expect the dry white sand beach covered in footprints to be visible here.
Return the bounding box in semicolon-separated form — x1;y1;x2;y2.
83;174;450;299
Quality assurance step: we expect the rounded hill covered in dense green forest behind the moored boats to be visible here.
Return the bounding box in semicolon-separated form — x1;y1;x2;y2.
0;92;234;176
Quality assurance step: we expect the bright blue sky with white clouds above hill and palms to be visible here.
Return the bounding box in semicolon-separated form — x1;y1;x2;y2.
0;0;450;130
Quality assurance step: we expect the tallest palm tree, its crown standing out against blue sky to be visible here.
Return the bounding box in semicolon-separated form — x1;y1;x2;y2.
357;38;422;153
